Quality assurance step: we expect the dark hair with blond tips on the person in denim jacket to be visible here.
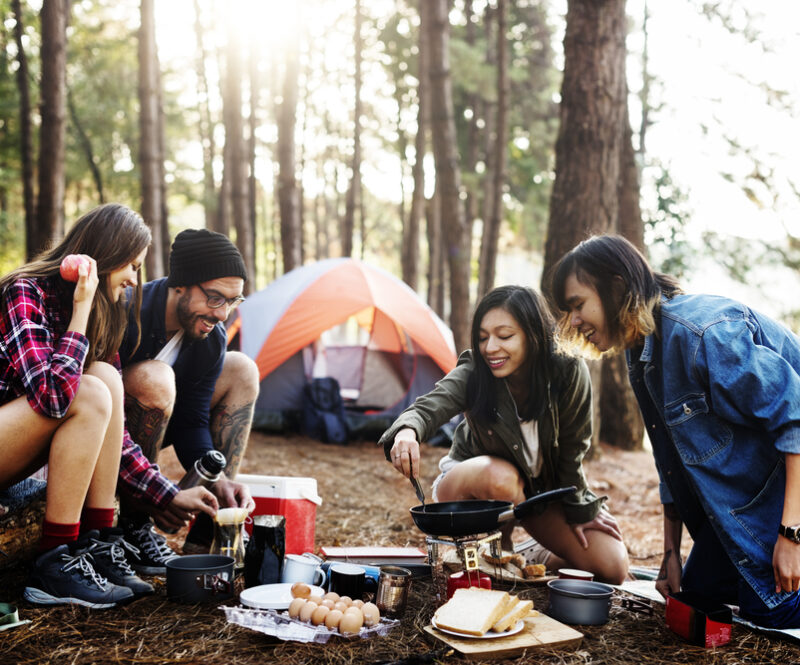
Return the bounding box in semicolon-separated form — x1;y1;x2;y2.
552;235;682;350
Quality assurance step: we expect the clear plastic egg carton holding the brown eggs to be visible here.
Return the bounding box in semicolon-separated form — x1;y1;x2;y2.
219;605;400;644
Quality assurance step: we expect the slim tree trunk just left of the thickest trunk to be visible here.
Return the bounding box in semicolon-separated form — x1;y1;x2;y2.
478;0;508;298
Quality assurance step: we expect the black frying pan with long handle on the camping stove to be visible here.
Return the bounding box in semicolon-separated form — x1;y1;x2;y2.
411;486;576;537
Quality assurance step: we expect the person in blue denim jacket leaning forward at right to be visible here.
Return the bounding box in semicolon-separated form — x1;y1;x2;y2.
553;236;800;628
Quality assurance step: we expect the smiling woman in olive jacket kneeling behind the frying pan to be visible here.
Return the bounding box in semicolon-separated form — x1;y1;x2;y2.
379;286;628;583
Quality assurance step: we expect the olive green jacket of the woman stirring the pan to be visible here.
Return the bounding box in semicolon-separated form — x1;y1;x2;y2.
378;351;605;524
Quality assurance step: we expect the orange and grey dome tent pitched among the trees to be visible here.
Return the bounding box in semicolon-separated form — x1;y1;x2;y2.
228;258;456;444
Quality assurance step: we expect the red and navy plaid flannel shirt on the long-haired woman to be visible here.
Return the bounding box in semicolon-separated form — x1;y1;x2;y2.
0;278;178;508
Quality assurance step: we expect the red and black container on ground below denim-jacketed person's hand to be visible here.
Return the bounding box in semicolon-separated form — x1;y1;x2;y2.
664;591;733;647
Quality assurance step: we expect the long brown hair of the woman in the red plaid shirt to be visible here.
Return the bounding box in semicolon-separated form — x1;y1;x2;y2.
0;203;151;362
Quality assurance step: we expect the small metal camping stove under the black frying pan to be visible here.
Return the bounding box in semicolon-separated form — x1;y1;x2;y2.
425;531;501;602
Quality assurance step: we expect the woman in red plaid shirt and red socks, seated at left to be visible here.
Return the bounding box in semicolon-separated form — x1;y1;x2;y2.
0;204;166;607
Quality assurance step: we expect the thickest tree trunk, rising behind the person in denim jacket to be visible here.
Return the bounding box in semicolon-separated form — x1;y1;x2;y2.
542;0;627;452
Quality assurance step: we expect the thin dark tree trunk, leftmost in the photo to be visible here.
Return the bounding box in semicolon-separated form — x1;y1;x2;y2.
11;0;38;259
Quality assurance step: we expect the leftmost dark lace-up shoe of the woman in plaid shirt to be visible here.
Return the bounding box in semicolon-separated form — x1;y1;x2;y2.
23;545;133;608
